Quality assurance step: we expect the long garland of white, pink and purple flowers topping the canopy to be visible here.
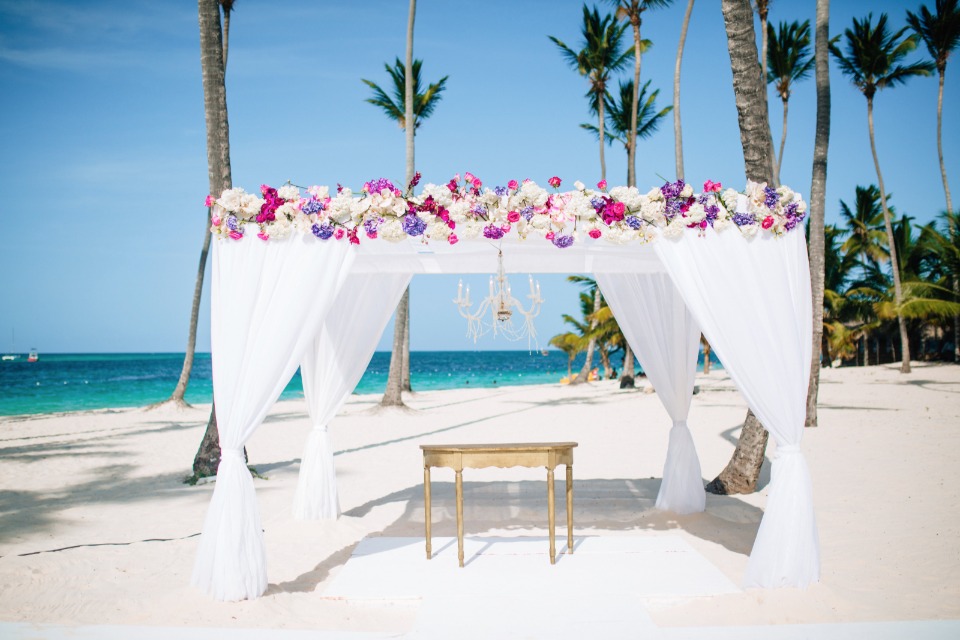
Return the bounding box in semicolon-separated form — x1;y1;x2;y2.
206;172;806;249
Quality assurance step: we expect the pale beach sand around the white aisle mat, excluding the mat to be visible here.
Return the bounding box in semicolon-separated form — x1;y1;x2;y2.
0;364;960;632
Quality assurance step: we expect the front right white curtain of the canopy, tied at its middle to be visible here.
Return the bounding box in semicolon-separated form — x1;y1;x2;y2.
654;229;820;587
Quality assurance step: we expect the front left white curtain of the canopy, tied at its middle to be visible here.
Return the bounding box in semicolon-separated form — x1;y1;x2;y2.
192;232;353;600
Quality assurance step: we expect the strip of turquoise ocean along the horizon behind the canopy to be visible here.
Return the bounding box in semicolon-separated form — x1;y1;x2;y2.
0;350;713;416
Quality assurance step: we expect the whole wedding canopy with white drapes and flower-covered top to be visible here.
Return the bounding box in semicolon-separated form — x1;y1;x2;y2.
193;179;820;600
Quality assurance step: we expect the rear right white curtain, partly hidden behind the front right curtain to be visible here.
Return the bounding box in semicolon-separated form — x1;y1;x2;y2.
595;273;706;513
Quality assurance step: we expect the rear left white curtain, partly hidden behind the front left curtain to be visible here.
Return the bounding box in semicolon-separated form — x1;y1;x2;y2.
293;273;410;520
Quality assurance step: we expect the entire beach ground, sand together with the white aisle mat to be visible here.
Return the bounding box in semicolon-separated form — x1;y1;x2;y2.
0;363;960;638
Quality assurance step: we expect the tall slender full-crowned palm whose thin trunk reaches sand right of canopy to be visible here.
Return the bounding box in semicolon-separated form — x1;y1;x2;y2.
830;13;933;373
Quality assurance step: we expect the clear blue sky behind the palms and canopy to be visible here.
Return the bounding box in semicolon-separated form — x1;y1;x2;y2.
0;0;960;352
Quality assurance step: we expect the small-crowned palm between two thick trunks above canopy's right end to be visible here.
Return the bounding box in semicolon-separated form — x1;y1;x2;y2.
767;20;813;182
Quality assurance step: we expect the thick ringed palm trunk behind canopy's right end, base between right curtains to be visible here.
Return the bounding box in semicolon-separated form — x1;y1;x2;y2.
705;0;773;494
